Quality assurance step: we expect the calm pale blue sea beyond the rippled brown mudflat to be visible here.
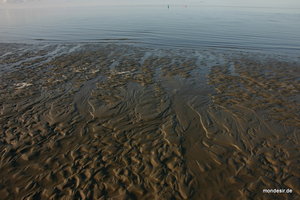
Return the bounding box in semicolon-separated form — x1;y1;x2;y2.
0;1;300;52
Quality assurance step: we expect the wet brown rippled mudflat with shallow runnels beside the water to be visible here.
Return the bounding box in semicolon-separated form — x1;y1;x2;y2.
0;44;300;199
